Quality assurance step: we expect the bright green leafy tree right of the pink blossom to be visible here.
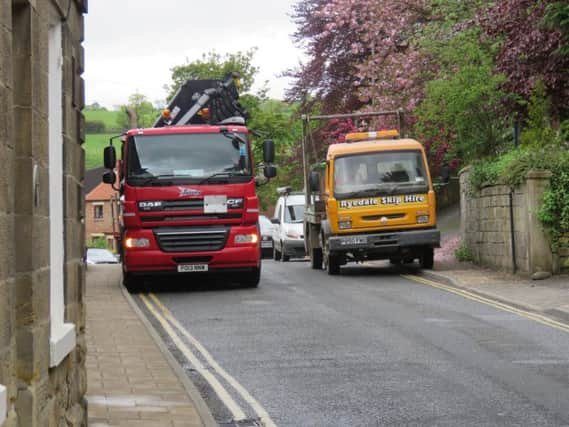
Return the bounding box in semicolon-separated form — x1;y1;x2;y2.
415;30;506;167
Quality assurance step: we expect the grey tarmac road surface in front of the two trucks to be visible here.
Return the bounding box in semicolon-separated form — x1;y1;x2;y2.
137;260;569;426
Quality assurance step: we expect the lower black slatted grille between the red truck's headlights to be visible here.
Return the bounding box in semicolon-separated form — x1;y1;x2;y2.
154;227;229;252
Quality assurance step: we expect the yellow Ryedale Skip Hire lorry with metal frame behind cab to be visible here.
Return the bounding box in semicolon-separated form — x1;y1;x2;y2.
302;111;440;274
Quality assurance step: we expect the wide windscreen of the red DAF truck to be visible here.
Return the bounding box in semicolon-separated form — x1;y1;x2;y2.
127;133;251;185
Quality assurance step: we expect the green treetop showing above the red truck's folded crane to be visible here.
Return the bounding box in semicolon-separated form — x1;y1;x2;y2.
166;48;259;100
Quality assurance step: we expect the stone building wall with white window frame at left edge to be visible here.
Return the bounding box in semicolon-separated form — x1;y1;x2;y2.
0;0;87;427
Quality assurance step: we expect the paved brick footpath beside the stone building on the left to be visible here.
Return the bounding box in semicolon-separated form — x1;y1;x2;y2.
85;265;217;427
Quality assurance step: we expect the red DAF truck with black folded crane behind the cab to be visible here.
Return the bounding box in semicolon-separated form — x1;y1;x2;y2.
103;75;276;292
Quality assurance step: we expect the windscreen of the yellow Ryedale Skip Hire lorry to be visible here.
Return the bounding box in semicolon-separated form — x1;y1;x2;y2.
334;151;428;199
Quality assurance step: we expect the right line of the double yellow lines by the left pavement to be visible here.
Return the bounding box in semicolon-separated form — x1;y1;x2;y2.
149;293;276;427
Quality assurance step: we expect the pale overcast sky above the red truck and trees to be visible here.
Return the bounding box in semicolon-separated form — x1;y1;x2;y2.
84;0;304;109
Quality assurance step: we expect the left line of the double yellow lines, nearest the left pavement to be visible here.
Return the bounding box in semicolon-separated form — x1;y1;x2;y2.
139;294;247;421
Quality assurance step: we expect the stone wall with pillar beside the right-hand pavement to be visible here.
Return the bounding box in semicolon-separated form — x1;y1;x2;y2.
460;168;569;274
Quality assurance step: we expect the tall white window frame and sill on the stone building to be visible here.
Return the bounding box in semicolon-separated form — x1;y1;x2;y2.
48;18;76;367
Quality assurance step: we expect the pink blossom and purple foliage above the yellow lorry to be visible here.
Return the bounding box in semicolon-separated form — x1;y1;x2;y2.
288;0;489;113
